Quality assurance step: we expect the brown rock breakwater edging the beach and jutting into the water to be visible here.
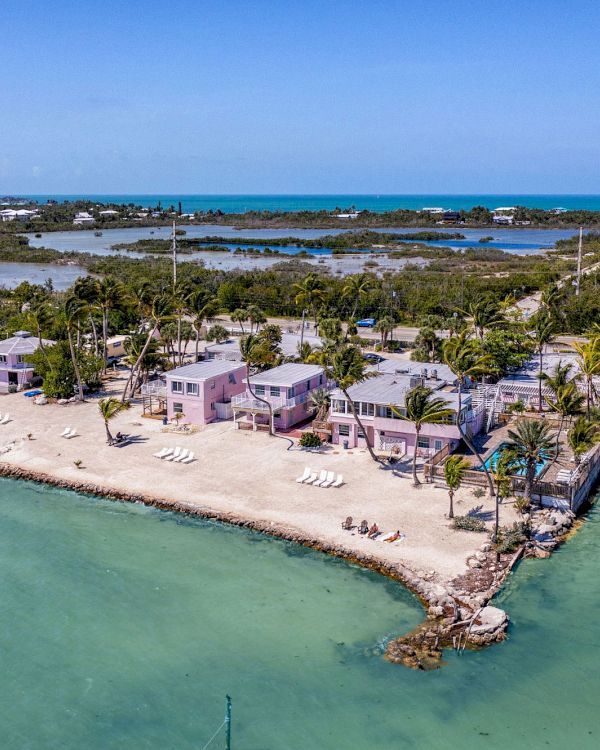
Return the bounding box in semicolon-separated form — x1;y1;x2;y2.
0;462;574;670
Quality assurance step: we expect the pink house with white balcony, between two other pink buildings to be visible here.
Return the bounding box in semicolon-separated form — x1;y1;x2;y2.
231;363;327;430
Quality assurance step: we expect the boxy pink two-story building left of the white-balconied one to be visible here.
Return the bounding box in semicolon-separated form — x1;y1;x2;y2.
166;360;246;425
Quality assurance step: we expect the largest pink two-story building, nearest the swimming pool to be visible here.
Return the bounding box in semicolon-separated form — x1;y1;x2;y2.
329;374;484;457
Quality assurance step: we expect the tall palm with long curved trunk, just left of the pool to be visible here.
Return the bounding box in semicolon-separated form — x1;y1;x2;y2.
444;331;494;497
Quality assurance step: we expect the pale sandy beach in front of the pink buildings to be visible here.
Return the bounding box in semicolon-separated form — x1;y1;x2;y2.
0;381;515;582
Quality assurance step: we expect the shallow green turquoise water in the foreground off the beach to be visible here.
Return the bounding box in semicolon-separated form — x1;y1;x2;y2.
0;480;600;750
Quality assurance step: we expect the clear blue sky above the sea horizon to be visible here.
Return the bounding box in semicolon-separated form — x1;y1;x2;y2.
0;0;600;195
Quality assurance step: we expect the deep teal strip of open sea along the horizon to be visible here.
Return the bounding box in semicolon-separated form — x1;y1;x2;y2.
17;193;600;213
